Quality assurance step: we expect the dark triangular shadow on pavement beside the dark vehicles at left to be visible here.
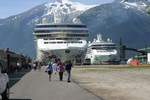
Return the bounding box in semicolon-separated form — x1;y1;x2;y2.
8;69;32;88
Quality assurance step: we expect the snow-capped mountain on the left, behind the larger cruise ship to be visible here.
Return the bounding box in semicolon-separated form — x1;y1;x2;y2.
0;0;95;57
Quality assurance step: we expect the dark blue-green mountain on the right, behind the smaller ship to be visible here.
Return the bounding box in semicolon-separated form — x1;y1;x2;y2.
78;0;150;57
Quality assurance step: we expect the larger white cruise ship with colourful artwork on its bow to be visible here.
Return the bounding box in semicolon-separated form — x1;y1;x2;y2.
33;14;89;63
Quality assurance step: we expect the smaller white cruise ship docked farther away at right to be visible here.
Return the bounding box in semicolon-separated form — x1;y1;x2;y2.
86;34;117;64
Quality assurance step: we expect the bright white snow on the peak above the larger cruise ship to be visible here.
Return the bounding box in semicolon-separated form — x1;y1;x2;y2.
39;0;96;21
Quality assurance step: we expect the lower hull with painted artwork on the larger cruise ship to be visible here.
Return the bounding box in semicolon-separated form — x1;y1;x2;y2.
37;48;86;63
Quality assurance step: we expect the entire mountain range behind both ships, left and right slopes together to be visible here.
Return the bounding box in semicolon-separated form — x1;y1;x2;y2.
0;0;150;57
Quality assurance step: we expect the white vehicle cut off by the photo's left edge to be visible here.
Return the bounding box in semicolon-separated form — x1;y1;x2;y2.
0;63;10;100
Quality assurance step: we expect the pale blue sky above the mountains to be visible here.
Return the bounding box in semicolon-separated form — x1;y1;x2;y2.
0;0;114;19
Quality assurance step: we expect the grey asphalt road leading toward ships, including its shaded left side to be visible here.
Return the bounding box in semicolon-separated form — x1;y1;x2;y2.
0;66;102;100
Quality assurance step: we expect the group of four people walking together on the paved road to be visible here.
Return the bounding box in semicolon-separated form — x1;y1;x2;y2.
45;61;73;83
